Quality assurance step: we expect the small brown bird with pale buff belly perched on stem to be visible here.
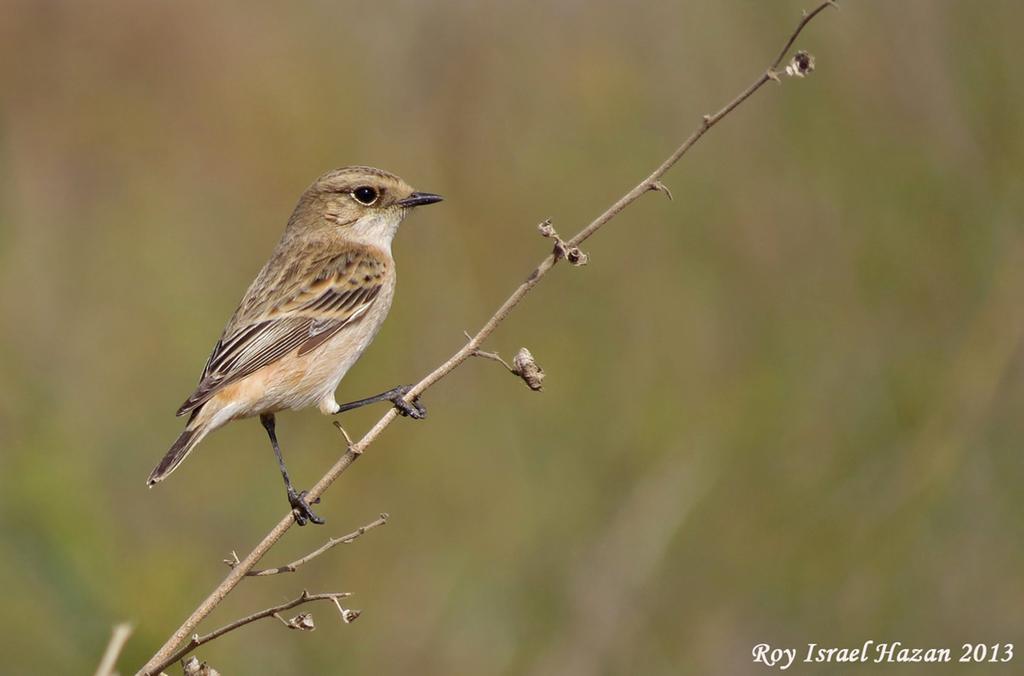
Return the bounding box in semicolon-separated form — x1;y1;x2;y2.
147;167;441;525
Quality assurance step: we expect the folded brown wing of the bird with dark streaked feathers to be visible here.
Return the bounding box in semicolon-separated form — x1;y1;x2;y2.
177;249;387;416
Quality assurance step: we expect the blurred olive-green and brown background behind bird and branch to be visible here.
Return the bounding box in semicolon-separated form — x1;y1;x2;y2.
0;0;1024;676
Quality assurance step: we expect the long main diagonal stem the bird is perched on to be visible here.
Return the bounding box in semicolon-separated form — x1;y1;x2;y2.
139;0;836;675
